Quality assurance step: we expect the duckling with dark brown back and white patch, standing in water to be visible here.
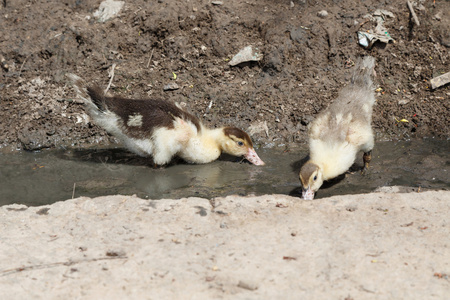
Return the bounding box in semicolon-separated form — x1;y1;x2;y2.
67;74;264;165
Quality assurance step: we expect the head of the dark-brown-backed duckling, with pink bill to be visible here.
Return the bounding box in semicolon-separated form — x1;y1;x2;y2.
220;127;264;166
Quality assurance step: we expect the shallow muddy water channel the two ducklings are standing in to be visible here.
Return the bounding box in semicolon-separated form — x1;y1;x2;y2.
0;139;450;205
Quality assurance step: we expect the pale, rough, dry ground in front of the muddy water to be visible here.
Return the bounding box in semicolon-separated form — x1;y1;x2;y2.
0;191;450;299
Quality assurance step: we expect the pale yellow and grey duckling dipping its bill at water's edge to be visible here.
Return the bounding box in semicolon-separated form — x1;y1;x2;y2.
299;56;375;200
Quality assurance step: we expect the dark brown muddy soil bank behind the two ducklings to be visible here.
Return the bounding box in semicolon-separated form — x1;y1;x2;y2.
0;0;450;152
